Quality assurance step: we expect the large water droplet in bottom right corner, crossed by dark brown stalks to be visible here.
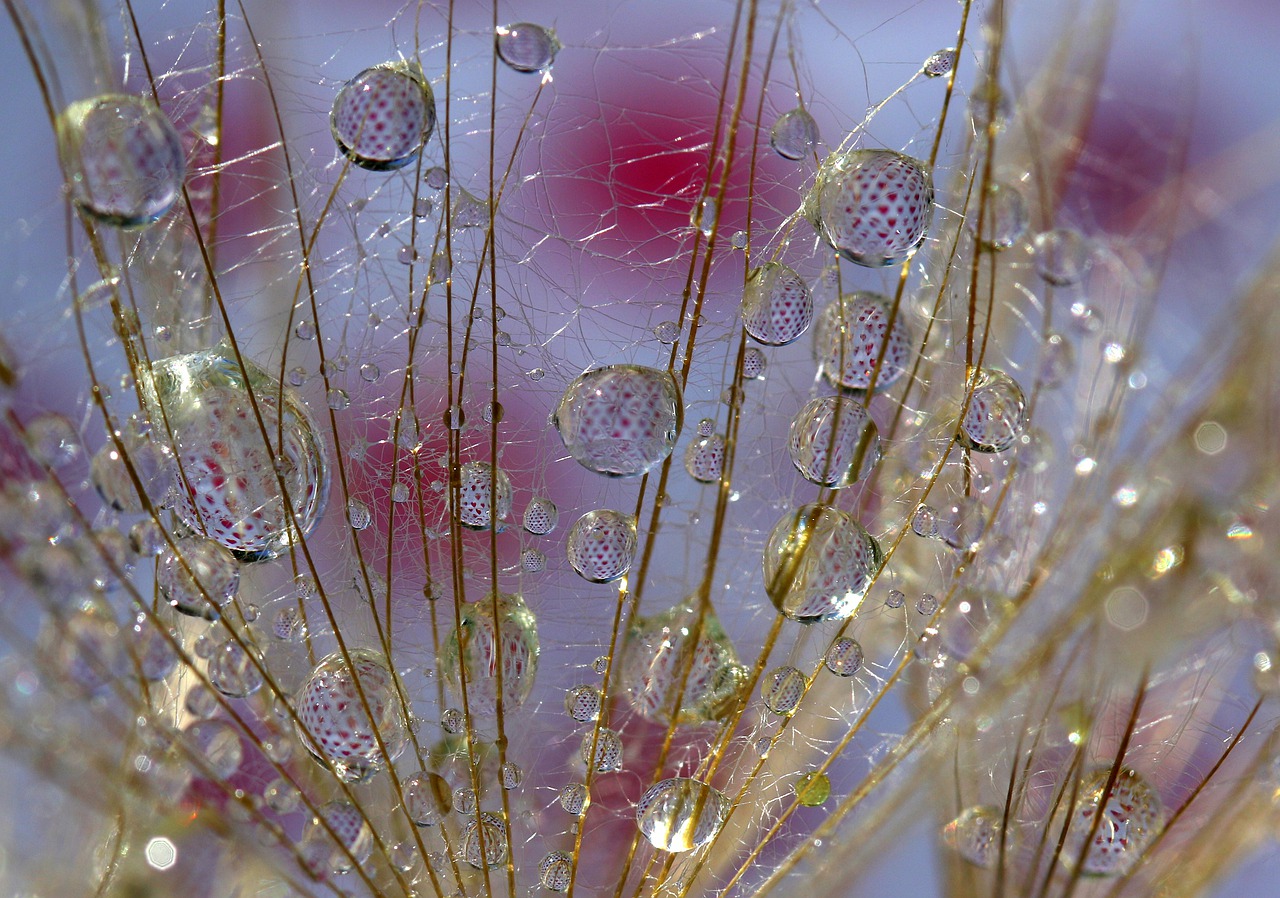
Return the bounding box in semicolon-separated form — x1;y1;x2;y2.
1061;768;1166;876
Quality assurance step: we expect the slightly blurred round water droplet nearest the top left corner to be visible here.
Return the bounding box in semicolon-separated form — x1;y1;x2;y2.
58;93;187;228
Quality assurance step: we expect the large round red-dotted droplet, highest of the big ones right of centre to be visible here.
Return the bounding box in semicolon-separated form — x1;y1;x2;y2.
804;150;933;269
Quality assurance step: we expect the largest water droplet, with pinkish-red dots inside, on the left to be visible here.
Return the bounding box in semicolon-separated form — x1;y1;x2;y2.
145;345;329;562
